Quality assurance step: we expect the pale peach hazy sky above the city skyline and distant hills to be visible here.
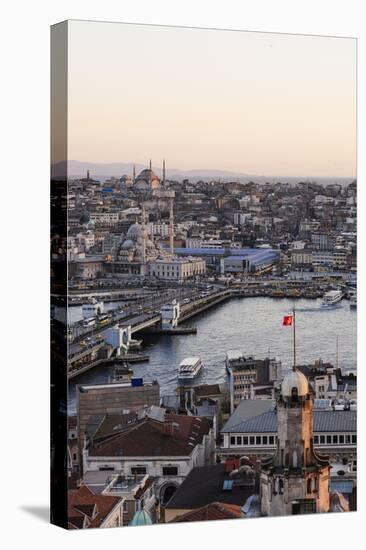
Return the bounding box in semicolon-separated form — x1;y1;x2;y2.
69;21;356;177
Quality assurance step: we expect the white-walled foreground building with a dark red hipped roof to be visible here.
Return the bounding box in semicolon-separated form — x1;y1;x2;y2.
83;409;214;504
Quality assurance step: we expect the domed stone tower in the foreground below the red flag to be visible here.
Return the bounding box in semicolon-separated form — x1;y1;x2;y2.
260;369;330;516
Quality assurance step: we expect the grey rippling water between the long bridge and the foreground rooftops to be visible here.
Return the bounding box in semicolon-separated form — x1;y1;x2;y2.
69;298;357;411
